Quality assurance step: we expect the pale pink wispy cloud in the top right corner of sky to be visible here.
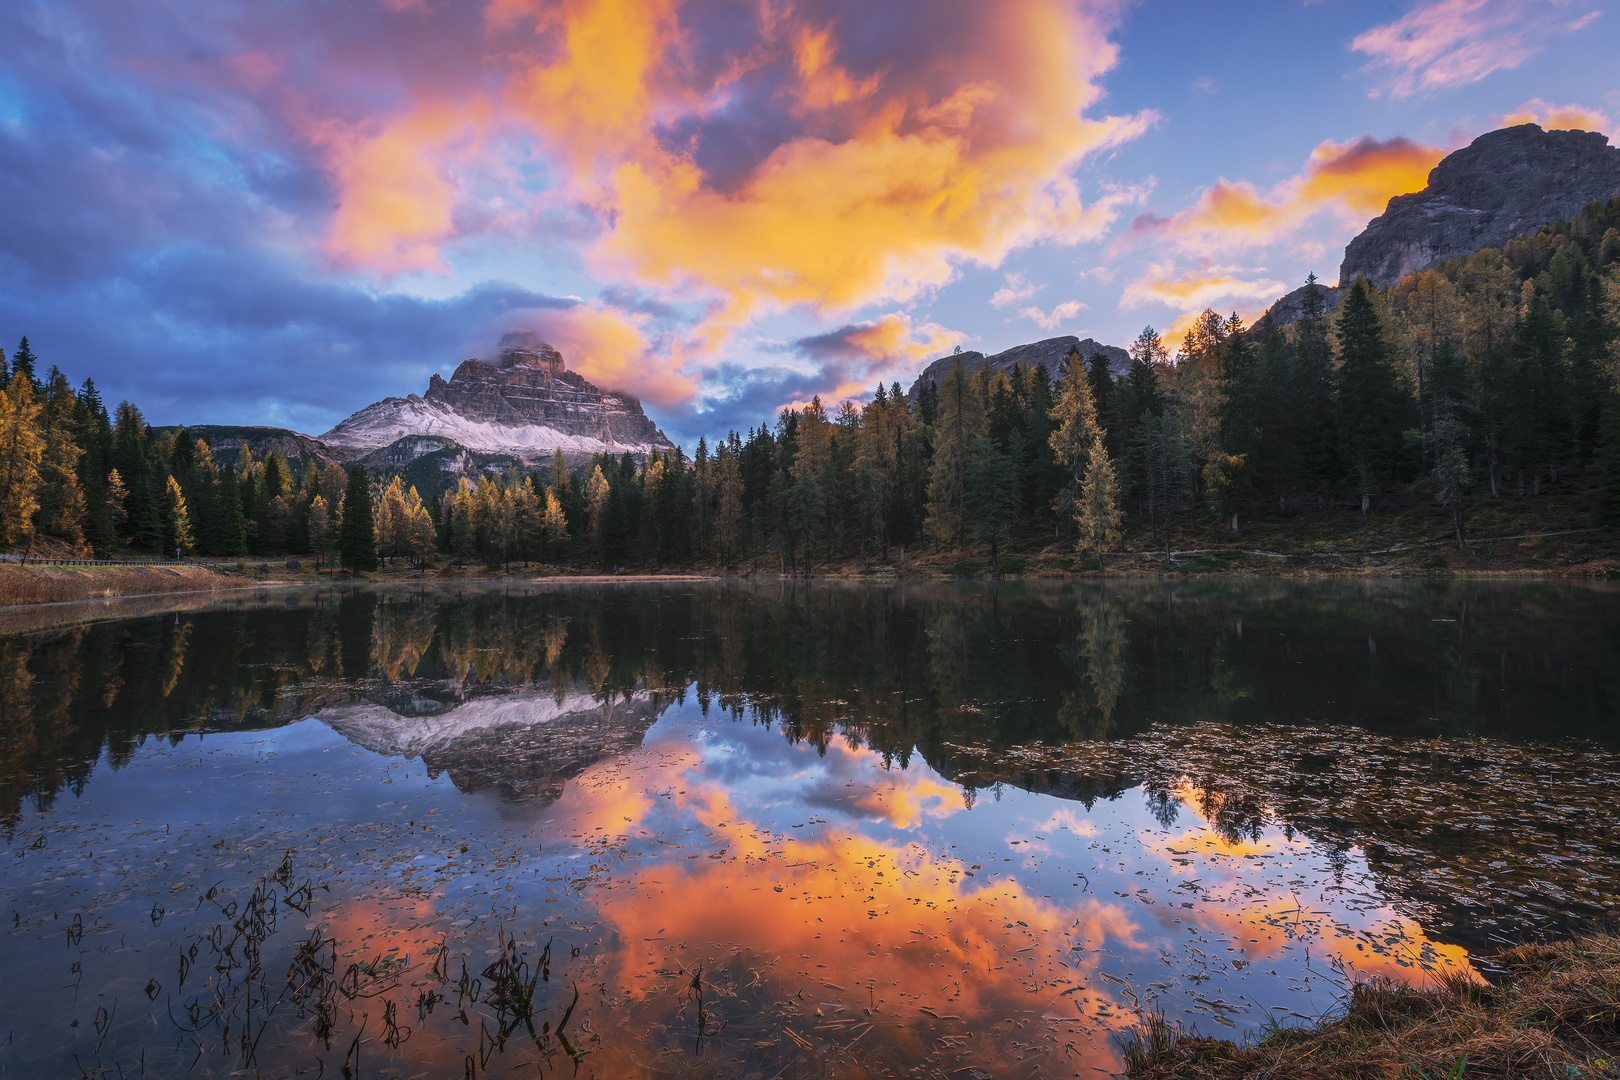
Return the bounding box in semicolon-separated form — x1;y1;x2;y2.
1349;0;1599;97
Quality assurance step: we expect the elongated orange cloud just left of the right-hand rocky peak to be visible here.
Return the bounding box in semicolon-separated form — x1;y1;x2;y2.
1115;134;1443;254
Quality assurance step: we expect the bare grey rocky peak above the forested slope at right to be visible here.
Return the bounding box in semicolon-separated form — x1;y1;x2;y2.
1338;123;1620;285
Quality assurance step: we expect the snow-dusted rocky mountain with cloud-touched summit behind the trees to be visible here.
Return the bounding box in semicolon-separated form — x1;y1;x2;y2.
321;330;674;465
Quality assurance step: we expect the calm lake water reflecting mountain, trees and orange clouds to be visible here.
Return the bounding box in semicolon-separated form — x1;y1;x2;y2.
0;581;1620;1080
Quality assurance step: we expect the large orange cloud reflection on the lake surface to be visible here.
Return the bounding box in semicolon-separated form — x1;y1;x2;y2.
554;742;1145;1075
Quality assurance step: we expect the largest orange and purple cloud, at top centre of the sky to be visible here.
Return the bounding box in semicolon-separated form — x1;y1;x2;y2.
275;0;1157;380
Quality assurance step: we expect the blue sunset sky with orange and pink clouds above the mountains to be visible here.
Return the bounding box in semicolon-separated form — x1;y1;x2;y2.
0;0;1620;449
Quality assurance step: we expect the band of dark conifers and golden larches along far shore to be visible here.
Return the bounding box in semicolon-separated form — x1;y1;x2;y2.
9;198;1620;573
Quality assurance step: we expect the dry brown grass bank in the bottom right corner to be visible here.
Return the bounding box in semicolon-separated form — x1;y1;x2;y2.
1124;934;1620;1080
